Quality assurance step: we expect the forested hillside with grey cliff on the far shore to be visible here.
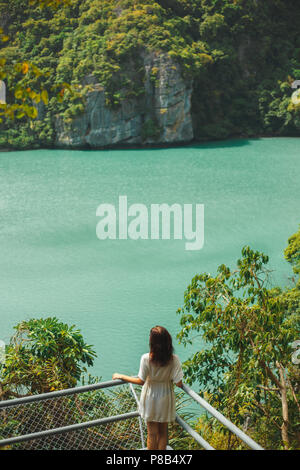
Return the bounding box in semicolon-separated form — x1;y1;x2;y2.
0;0;300;148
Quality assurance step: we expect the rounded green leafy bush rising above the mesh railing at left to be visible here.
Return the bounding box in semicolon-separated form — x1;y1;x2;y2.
0;317;96;396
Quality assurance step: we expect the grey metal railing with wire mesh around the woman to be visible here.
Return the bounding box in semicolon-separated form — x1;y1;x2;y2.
0;380;263;450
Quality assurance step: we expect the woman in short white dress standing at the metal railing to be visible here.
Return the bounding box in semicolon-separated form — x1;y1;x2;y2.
112;326;183;450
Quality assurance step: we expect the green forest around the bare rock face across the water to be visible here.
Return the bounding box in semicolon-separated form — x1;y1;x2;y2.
0;0;300;148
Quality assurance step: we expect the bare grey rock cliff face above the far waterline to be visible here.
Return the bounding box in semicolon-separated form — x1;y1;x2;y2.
56;53;193;148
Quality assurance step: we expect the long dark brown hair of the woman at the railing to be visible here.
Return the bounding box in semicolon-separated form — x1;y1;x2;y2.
149;326;174;367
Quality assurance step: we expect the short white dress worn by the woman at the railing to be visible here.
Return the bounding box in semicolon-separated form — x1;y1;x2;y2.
138;353;183;423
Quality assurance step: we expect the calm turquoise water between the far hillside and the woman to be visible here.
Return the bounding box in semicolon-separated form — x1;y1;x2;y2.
0;138;300;379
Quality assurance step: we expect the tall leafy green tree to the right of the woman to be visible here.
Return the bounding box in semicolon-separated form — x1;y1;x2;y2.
178;234;300;449
